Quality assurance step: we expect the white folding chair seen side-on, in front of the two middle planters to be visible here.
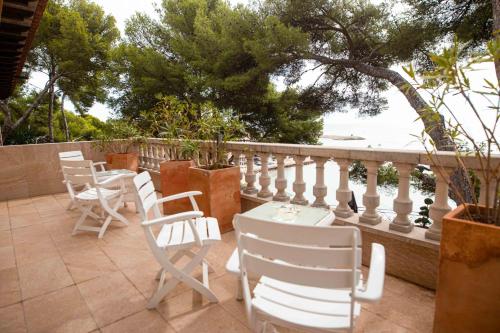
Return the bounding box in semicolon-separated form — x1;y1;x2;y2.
134;171;221;309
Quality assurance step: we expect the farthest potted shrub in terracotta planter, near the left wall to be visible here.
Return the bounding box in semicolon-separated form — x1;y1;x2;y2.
94;120;145;172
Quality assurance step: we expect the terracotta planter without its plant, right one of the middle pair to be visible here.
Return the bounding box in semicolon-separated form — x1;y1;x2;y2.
188;166;241;232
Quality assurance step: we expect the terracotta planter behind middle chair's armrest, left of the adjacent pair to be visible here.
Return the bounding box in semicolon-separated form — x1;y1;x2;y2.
160;161;195;214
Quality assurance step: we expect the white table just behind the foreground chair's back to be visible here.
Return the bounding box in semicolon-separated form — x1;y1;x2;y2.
226;201;335;301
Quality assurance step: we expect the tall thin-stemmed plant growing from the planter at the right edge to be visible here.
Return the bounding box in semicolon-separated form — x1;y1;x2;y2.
404;39;500;225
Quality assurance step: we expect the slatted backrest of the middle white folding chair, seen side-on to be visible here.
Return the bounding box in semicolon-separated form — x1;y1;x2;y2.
134;171;162;221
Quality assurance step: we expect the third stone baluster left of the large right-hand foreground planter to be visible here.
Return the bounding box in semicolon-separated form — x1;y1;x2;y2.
359;161;382;225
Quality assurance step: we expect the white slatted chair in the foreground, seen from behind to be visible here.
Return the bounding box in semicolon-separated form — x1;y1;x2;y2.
233;215;385;332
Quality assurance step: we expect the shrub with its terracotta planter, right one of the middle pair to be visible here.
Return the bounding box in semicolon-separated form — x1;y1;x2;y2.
188;104;244;232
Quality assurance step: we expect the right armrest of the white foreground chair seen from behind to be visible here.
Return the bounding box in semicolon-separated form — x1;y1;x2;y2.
354;243;385;302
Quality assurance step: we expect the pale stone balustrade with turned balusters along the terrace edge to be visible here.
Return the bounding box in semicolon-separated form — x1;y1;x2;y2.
140;139;500;241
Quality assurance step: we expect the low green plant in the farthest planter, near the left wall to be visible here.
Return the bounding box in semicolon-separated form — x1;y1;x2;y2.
93;120;146;154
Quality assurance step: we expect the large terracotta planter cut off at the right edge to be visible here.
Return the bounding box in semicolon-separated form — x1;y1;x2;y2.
434;206;500;333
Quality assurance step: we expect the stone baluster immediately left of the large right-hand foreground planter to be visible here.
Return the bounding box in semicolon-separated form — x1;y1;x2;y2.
425;167;452;241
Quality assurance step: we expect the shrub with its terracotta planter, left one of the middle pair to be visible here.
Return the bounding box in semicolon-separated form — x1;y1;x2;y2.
144;96;200;214
